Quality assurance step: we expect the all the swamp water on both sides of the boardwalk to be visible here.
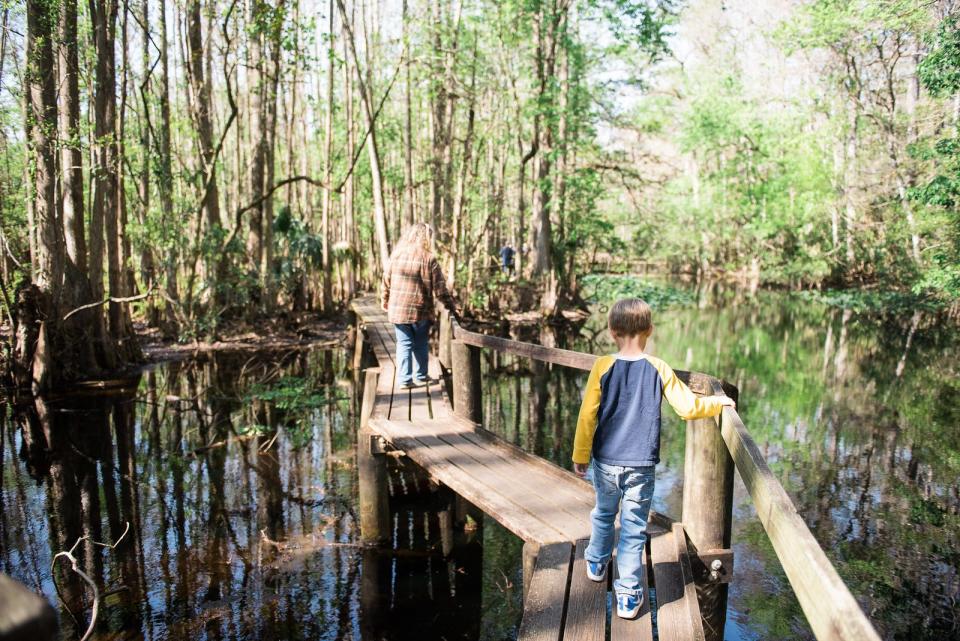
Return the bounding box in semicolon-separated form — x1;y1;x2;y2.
0;290;960;640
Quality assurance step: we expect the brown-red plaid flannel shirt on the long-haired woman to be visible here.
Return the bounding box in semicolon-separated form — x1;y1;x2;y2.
382;251;455;323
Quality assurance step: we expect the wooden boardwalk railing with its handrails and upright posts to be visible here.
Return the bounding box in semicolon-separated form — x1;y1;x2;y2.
440;316;880;641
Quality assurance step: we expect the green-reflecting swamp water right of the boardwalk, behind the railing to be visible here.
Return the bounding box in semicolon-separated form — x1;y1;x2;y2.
484;288;960;641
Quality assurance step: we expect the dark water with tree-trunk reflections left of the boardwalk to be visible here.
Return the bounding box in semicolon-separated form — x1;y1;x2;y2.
0;351;520;639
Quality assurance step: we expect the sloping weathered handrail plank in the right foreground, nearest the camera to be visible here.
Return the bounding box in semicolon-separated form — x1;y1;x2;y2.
717;392;880;641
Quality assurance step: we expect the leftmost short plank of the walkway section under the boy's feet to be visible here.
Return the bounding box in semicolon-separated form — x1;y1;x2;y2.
517;543;573;641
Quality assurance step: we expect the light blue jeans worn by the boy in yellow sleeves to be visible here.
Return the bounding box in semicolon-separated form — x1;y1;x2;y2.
583;461;655;595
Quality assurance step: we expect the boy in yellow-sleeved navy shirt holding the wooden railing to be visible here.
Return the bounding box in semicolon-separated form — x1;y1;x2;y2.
573;298;735;619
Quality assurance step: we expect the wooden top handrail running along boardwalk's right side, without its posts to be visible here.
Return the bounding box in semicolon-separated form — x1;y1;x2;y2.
450;318;880;641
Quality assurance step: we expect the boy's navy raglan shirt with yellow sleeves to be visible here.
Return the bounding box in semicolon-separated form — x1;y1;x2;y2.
573;354;723;467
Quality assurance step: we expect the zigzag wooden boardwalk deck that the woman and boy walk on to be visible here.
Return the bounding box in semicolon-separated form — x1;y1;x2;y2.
353;297;705;641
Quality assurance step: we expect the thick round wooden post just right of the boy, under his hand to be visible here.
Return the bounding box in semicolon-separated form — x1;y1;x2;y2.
682;385;733;641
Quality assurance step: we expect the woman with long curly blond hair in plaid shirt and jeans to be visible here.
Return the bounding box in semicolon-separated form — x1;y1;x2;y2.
383;223;457;389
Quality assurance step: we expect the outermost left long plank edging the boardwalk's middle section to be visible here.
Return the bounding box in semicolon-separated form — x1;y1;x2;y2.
370;420;565;544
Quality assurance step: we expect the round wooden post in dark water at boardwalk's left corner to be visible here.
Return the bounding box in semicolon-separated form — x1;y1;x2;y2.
357;367;390;544
